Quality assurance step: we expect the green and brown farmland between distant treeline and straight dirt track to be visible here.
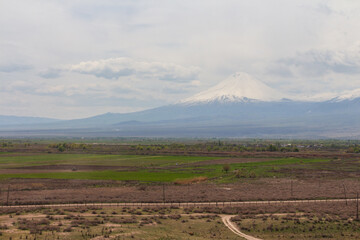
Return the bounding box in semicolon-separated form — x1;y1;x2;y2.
0;145;360;204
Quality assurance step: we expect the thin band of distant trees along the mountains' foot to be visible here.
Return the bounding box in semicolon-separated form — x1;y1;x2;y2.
0;139;360;153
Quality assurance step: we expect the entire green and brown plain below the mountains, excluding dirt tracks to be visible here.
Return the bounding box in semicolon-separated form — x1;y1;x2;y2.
0;141;360;239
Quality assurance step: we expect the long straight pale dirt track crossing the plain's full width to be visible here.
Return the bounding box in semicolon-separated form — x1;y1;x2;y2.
0;198;358;209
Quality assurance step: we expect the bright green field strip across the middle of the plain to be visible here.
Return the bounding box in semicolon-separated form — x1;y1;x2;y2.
0;154;331;182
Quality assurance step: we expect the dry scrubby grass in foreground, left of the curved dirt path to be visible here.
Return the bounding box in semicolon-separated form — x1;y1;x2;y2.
0;207;237;240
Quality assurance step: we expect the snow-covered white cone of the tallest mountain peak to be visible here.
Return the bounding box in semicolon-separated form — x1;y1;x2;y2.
181;72;284;104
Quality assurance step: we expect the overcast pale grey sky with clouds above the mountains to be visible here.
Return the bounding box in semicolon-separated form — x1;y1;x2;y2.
0;0;360;119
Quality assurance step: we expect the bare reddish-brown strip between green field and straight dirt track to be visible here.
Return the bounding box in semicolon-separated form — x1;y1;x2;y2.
0;179;360;204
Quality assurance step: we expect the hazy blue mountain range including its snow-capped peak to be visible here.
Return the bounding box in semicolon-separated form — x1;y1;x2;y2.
0;73;360;138
